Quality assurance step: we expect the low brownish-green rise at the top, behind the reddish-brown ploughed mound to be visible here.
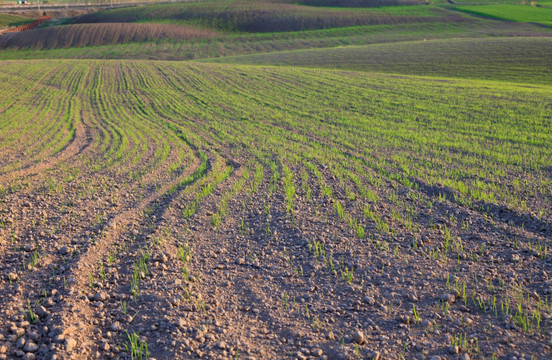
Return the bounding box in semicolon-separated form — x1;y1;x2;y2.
73;1;469;33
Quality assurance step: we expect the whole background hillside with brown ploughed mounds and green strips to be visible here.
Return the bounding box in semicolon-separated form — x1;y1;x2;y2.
0;2;552;60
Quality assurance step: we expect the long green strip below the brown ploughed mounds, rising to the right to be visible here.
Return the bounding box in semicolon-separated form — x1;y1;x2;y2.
0;19;552;60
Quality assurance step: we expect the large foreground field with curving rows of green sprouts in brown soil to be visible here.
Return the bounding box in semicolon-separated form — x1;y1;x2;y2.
0;60;552;359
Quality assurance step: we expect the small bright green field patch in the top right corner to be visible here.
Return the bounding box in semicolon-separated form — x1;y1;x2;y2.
456;5;552;26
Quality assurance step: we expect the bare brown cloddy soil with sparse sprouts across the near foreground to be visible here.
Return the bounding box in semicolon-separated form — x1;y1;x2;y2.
0;64;552;360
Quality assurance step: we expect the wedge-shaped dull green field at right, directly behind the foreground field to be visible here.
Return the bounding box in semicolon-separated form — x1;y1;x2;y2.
212;37;552;84
